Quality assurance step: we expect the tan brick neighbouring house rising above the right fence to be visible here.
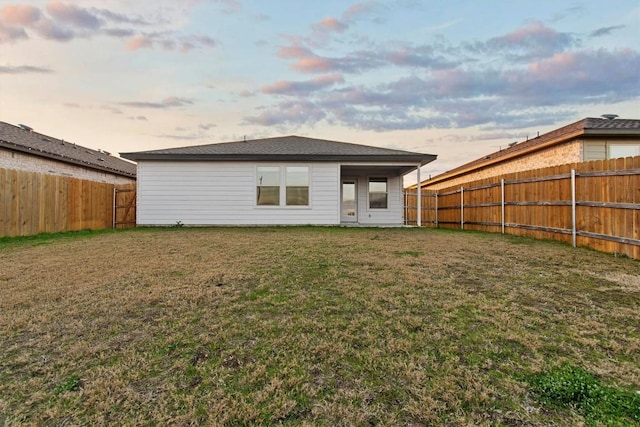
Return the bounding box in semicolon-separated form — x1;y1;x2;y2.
412;116;640;190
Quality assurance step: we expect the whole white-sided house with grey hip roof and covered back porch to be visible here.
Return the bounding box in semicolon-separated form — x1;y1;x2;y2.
121;136;436;225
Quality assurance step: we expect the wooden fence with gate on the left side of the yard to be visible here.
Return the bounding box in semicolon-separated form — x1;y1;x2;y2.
0;169;136;237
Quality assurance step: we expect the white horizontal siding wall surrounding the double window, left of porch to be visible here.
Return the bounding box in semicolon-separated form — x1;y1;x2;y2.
137;161;340;225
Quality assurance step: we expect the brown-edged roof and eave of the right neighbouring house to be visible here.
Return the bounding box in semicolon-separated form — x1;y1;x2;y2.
422;117;640;185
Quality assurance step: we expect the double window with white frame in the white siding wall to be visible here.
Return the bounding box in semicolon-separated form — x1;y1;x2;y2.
256;166;309;206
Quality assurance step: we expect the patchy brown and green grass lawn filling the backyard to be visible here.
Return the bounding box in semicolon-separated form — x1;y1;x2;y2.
0;227;640;426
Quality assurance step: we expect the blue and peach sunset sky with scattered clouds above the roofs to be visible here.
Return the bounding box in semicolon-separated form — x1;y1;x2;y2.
0;0;640;182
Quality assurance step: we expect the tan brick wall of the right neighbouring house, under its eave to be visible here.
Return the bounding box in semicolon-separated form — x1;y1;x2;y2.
423;139;582;190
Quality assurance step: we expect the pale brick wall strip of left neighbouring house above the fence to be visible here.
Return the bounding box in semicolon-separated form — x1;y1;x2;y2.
0;148;135;184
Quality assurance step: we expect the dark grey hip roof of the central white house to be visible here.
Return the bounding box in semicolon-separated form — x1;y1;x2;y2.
120;135;437;165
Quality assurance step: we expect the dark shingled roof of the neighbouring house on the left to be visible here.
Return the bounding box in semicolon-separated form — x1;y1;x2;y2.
0;122;136;178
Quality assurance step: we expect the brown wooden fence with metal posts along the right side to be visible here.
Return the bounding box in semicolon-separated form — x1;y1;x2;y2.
405;156;640;259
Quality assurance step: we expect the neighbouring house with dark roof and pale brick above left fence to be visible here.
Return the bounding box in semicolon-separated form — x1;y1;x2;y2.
0;122;136;184
